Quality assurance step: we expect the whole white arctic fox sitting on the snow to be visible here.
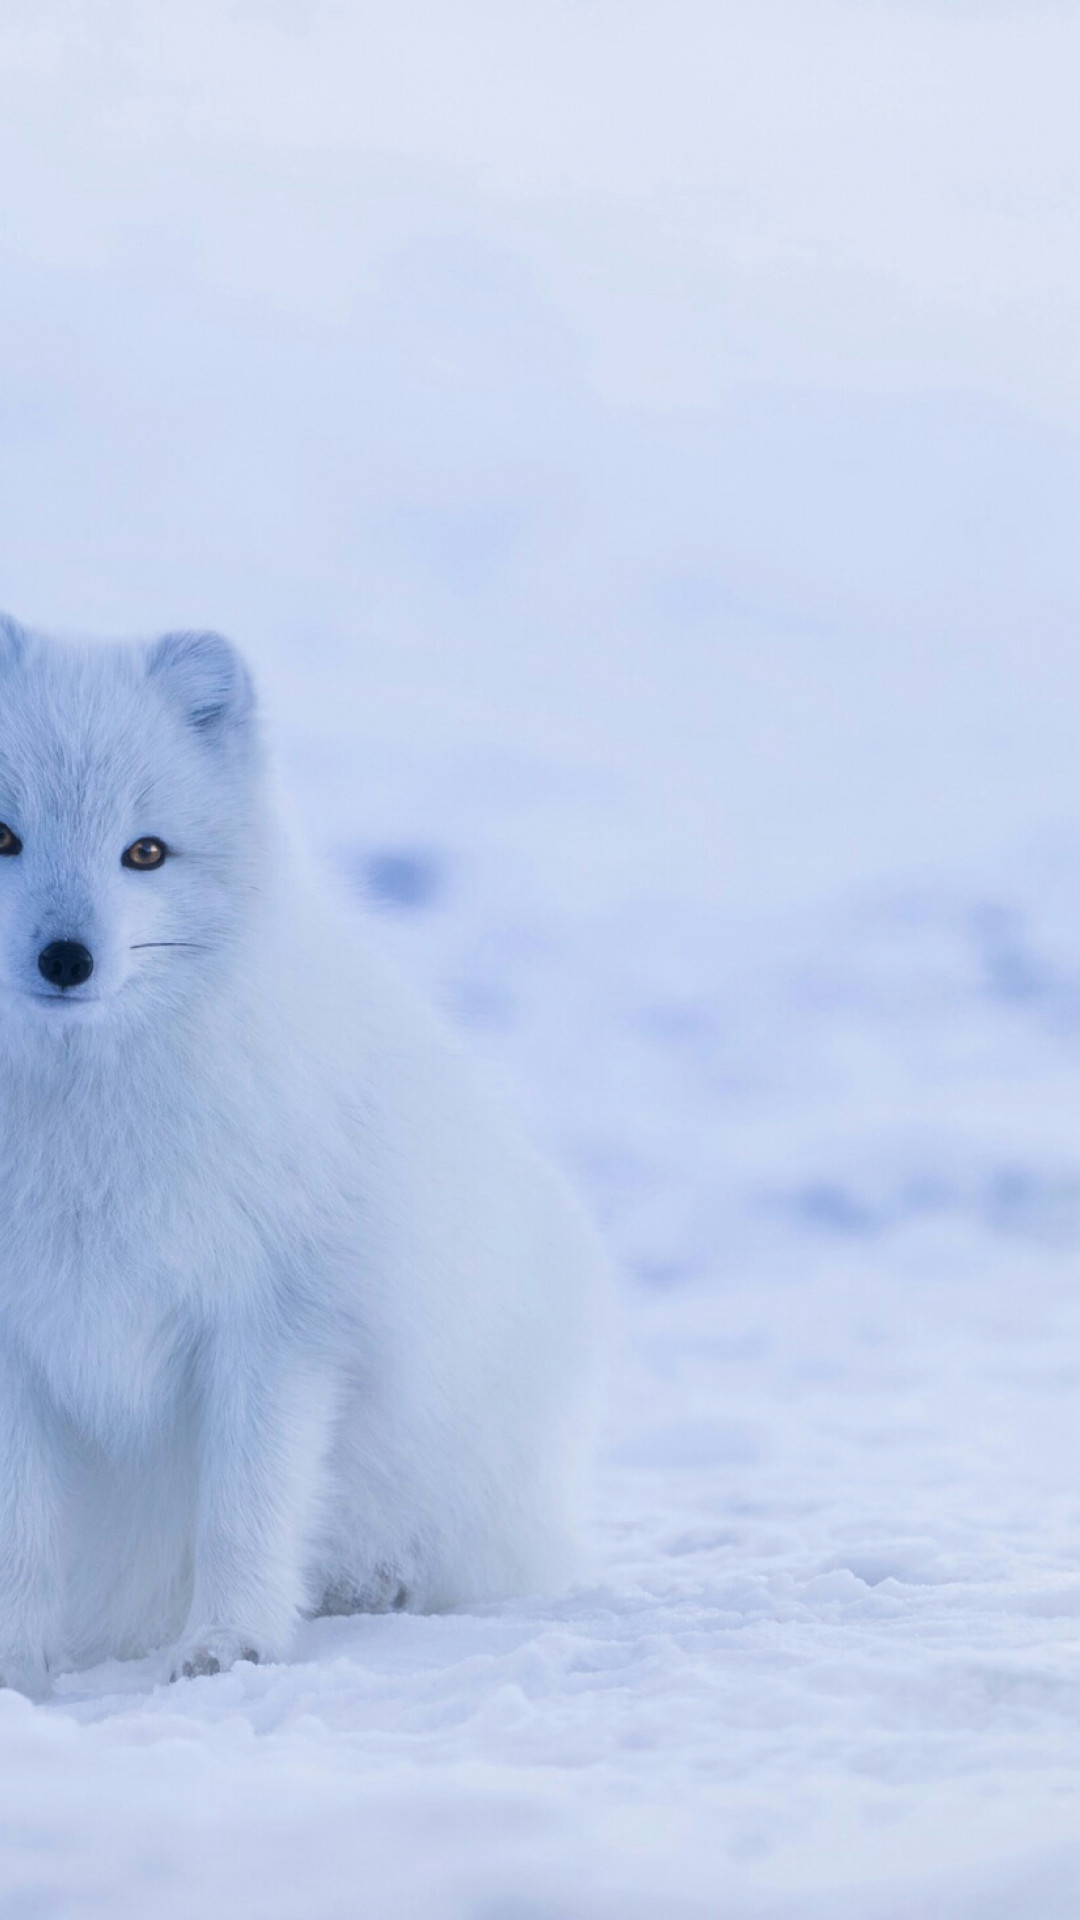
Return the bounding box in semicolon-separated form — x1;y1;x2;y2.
0;620;601;1693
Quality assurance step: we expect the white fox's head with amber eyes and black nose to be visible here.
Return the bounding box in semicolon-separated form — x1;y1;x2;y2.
0;618;261;1029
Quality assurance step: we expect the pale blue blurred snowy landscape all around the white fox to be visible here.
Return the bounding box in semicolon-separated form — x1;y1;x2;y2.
0;0;1080;1920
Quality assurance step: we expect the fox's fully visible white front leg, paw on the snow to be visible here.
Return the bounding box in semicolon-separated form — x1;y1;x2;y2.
171;1327;332;1680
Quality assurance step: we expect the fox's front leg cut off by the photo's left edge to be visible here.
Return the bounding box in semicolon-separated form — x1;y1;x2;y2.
0;1350;63;1697
